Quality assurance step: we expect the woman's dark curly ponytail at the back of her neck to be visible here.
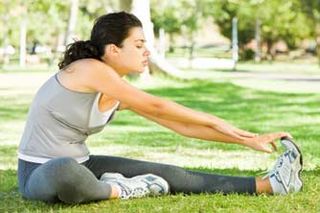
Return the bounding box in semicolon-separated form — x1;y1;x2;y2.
58;40;101;69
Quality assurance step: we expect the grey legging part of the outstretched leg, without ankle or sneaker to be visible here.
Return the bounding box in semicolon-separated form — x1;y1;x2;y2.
84;156;260;194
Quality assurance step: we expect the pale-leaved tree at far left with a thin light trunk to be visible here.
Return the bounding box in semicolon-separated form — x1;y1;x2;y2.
0;0;71;65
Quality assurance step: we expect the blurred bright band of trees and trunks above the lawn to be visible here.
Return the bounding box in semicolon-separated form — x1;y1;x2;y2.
0;0;320;74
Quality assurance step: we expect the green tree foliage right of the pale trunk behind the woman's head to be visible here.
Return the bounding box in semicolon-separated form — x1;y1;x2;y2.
152;0;320;56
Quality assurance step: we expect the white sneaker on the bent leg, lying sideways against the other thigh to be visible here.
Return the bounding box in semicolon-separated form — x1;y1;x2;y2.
100;172;169;199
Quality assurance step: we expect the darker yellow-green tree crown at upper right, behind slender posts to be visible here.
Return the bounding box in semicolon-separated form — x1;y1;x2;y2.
208;0;310;59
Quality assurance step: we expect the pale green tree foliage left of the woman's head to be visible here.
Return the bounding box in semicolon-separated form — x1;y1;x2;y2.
0;0;110;48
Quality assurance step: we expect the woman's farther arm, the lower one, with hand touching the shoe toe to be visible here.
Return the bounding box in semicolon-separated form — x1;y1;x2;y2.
130;108;291;153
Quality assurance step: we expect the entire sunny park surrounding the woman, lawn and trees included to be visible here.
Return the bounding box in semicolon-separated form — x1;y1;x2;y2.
0;0;320;212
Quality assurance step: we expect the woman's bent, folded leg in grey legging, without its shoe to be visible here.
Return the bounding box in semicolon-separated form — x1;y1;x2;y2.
19;158;112;203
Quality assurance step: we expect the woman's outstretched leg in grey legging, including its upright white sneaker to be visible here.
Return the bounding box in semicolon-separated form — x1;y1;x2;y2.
85;138;303;194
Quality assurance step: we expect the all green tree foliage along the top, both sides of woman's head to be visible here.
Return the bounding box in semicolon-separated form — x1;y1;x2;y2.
0;0;320;60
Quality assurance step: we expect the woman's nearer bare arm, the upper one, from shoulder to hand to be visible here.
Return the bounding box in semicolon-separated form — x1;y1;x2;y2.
77;59;243;140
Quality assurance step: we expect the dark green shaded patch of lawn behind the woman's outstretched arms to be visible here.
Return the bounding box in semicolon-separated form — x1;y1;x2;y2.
113;80;320;125
